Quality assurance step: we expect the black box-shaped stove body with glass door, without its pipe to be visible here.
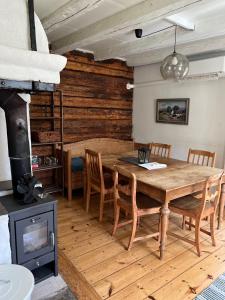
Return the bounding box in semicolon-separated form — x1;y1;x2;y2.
0;195;58;282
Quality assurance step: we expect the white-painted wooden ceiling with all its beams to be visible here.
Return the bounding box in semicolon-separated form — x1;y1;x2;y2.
35;0;225;66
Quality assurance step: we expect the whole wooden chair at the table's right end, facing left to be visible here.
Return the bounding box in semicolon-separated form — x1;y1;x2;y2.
169;172;223;256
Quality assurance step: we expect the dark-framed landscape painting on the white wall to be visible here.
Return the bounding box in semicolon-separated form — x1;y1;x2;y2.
156;98;190;125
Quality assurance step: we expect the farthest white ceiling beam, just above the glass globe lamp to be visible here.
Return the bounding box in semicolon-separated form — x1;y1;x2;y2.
127;35;225;66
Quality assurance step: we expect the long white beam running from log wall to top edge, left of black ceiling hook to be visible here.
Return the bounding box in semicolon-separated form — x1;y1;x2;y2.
52;0;204;53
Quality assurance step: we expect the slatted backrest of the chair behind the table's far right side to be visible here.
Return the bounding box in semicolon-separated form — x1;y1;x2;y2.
187;149;216;167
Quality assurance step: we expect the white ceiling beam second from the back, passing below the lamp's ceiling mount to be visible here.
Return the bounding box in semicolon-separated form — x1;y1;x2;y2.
92;13;225;60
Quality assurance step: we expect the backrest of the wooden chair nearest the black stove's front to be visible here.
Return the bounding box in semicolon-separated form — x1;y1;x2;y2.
114;166;137;212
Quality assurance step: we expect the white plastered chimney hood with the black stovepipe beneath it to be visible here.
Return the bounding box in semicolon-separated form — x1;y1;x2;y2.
0;0;66;200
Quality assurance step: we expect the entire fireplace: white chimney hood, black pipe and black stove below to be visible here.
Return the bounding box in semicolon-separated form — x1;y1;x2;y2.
0;0;66;282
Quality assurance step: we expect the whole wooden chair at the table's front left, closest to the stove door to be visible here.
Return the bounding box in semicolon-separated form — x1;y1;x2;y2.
112;166;161;250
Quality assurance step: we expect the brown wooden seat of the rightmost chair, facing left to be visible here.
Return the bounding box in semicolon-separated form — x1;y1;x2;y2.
169;195;214;216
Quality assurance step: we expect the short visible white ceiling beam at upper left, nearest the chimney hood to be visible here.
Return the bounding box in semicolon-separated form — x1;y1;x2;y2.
42;0;104;34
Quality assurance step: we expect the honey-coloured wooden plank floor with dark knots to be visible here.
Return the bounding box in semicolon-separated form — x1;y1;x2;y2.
58;197;225;300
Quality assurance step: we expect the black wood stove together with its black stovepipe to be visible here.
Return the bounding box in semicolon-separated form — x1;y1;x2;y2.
0;87;58;282
